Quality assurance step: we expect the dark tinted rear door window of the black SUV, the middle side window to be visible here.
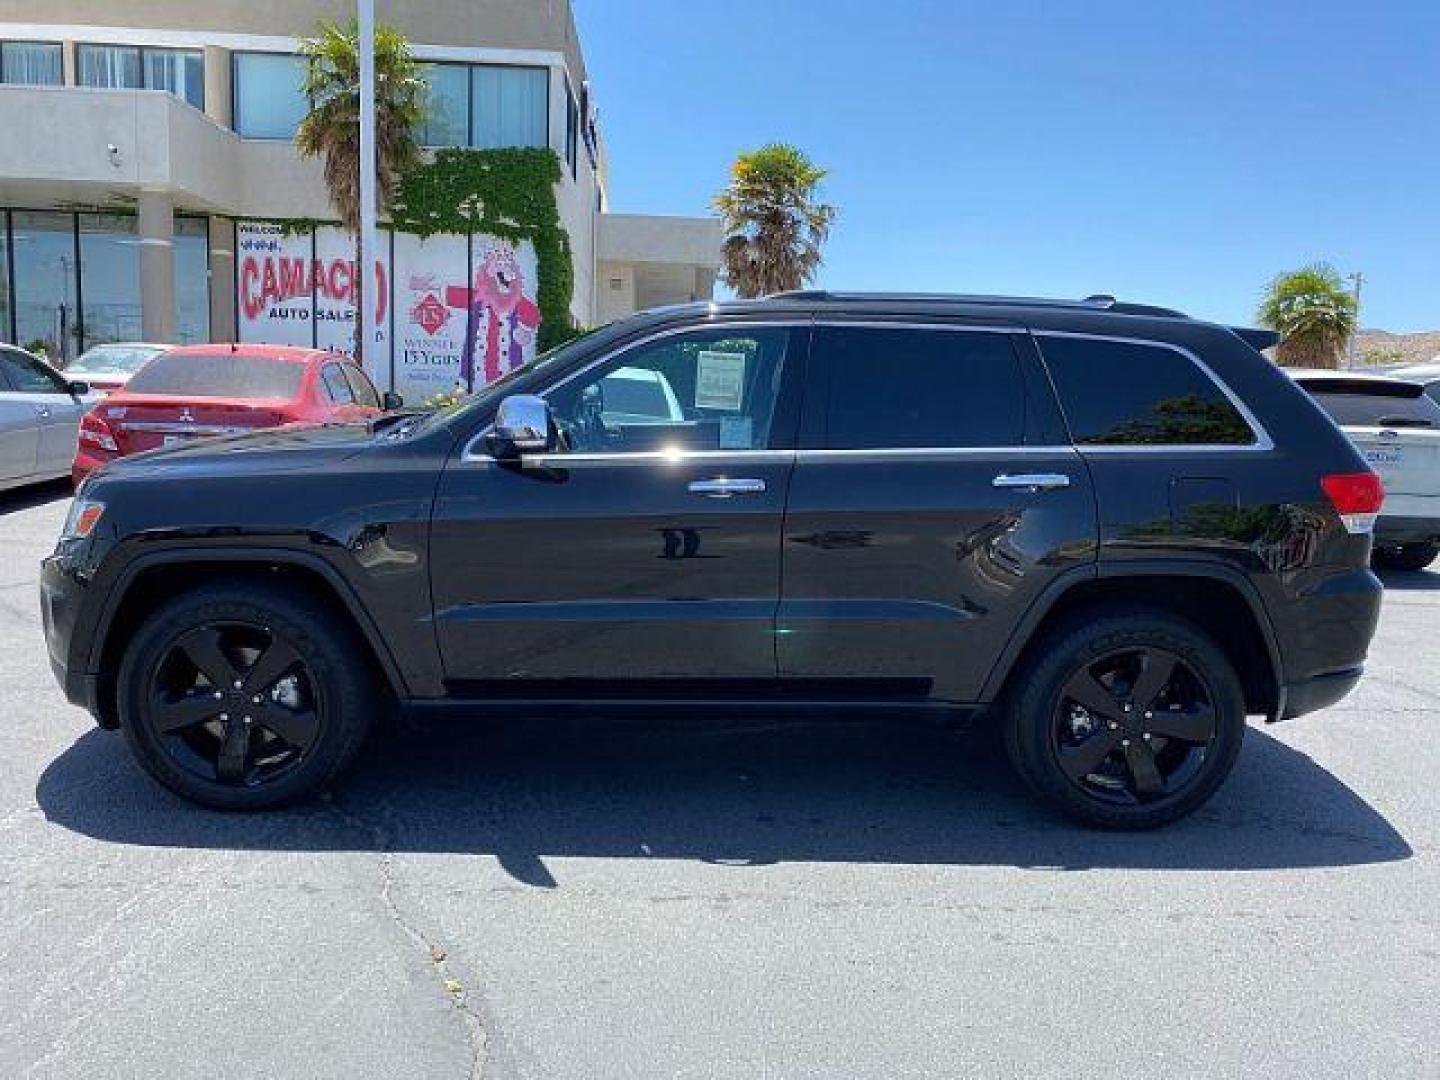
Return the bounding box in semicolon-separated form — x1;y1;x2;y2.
812;327;1025;449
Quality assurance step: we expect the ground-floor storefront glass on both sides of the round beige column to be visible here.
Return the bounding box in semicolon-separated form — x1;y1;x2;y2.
0;210;210;357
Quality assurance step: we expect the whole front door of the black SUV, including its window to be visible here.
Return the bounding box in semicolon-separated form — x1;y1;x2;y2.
431;324;806;696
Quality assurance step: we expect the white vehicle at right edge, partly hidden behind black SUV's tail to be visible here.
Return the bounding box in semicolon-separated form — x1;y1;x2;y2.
1289;369;1440;570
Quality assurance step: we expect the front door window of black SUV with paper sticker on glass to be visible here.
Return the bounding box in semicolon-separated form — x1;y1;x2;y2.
547;327;791;454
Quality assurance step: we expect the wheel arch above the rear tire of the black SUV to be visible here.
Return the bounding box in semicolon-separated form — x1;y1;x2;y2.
982;560;1286;720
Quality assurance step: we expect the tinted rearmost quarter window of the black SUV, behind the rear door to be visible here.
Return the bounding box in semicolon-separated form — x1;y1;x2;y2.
1037;334;1256;446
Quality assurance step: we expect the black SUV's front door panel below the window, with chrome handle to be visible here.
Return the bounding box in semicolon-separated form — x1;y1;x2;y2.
431;452;792;681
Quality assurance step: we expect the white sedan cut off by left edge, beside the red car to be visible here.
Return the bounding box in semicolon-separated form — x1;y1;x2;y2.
0;346;101;490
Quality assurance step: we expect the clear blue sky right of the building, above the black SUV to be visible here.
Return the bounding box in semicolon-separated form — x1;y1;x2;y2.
575;0;1440;330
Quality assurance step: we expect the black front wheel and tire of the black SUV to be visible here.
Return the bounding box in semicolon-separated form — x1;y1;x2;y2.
117;582;383;811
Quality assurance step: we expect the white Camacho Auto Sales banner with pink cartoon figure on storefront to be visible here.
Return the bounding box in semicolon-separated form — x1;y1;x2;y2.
236;222;540;405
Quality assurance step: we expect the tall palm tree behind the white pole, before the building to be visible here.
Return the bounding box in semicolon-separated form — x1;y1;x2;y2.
295;20;429;360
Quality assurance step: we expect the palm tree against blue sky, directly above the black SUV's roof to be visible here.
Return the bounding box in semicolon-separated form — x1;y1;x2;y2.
713;143;835;298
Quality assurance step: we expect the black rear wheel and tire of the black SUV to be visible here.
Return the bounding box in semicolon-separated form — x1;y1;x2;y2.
1005;608;1246;829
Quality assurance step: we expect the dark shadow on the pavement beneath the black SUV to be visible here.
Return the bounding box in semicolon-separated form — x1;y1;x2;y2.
36;721;1411;887
